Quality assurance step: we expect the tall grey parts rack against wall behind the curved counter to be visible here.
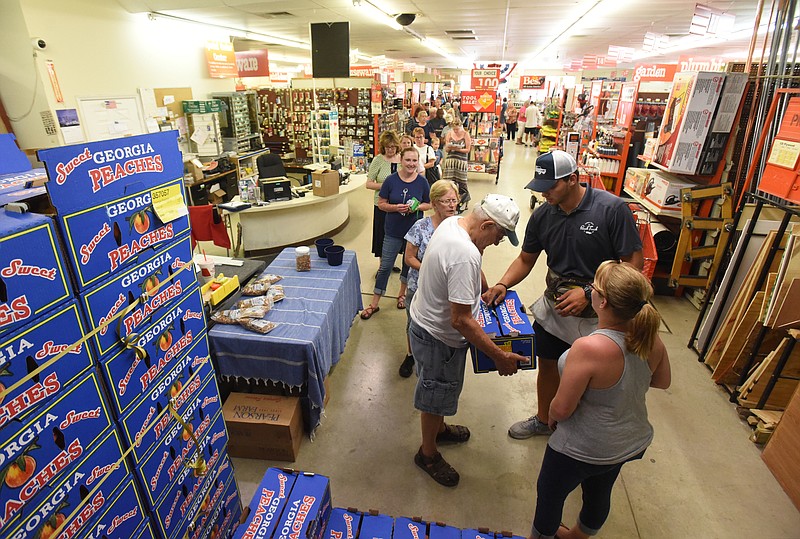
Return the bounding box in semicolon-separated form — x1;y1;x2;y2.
211;90;264;153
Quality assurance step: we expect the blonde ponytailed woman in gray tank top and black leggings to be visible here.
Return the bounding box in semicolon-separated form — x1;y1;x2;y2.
531;260;671;539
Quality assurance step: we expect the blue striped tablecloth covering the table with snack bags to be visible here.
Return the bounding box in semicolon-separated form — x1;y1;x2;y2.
208;247;362;432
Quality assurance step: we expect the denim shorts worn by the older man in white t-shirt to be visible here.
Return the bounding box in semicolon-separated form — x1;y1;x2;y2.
408;320;467;416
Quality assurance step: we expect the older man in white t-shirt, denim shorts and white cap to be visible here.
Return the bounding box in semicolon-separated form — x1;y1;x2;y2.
408;195;527;487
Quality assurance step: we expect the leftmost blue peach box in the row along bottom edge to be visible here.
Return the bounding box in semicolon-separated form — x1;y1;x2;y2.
234;468;302;539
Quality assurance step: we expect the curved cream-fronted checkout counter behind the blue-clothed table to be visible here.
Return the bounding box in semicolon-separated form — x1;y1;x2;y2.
230;174;367;256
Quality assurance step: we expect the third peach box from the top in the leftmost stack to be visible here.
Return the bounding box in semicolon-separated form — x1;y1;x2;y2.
0;370;112;530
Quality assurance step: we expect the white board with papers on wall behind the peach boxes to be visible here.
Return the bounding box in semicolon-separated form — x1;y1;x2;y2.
77;95;147;141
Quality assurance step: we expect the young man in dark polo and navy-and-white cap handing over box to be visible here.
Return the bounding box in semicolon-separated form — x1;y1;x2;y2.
483;150;644;440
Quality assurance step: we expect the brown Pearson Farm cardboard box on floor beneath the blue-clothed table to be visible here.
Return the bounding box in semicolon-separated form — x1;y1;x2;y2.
222;393;303;462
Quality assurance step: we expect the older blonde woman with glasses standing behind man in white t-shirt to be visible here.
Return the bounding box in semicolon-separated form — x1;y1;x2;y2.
400;180;458;378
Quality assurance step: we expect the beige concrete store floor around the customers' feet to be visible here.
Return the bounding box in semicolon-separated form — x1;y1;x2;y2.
228;141;800;539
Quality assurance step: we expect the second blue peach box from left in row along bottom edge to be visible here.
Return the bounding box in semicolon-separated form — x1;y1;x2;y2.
273;472;331;539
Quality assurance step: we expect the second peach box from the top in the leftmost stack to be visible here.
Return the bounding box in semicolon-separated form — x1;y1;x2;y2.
0;300;93;430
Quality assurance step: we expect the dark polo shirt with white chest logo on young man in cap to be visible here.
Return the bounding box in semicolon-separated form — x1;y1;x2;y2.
522;186;642;280
